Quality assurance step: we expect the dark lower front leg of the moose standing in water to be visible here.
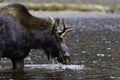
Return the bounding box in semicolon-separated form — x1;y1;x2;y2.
12;59;24;70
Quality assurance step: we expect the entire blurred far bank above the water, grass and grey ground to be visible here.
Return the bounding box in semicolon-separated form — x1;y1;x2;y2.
0;0;120;13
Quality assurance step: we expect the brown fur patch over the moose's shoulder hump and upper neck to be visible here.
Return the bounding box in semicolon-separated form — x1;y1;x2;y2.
0;4;52;30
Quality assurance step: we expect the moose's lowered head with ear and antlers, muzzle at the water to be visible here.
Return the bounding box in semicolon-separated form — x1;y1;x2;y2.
38;18;72;64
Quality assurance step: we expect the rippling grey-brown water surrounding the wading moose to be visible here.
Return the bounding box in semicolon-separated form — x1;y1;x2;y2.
0;13;120;80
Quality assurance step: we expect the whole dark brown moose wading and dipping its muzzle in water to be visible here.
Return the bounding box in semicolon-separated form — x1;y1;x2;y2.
0;4;72;70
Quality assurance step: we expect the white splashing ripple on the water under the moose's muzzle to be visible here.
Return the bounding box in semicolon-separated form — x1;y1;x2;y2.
25;64;85;70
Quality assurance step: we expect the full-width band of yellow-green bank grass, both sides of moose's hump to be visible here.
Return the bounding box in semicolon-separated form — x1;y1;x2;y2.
0;3;120;13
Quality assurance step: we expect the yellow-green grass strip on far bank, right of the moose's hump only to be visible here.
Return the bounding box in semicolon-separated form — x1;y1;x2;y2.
24;3;110;12
